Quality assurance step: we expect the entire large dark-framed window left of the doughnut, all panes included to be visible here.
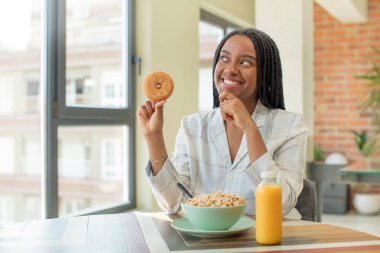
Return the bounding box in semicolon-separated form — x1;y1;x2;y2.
0;0;135;227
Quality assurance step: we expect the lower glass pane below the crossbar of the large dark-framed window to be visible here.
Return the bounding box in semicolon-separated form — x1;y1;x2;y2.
58;126;129;216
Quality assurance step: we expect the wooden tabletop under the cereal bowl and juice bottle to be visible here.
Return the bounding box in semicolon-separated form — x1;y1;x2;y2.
0;213;380;253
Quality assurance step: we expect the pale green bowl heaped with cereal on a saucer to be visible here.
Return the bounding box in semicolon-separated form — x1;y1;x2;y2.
181;192;246;231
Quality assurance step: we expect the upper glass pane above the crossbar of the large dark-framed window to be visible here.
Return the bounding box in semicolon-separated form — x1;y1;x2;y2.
66;0;126;108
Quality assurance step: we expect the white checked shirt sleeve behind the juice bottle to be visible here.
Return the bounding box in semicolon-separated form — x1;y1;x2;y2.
244;114;308;216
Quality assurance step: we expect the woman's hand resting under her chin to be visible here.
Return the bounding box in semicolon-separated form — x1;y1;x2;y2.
219;91;255;131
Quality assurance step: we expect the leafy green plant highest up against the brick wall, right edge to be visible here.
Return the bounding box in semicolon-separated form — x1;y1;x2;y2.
356;47;380;133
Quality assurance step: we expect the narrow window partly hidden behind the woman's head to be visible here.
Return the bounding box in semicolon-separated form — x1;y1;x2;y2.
198;10;239;111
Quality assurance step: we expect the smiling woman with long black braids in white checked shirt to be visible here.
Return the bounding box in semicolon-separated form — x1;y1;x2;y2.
137;29;307;218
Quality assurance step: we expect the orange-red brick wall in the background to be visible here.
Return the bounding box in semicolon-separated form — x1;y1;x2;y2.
314;0;380;166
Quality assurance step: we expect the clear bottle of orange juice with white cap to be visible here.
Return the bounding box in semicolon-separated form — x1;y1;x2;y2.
256;171;282;244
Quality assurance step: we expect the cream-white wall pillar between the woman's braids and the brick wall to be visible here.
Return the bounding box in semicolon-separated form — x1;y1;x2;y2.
255;0;314;160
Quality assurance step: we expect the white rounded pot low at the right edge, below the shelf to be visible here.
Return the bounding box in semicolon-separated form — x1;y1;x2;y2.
354;193;380;214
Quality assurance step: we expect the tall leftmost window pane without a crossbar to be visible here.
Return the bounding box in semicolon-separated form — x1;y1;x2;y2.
0;0;42;227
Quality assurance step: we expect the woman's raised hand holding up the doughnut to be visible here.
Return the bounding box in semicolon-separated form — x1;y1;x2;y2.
136;100;166;137
